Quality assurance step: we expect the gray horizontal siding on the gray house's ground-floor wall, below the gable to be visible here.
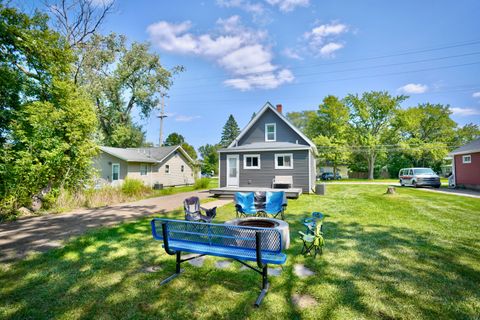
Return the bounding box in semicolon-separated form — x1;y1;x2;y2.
220;150;311;192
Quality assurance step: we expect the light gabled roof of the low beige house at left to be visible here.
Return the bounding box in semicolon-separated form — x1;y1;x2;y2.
100;145;195;164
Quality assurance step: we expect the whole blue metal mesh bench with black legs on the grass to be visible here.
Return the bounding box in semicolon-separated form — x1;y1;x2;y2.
151;218;287;307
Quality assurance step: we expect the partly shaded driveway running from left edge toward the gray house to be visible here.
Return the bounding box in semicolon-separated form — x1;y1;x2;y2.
0;191;232;263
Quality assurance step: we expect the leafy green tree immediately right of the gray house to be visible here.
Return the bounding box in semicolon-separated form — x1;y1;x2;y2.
307;96;350;174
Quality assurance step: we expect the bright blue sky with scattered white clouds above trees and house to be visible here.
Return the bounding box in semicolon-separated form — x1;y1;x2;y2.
19;0;480;147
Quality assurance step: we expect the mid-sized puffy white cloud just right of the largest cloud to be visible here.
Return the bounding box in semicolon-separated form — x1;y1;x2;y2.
303;22;348;57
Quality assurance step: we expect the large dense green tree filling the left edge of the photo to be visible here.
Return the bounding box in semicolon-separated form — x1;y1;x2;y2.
0;3;97;212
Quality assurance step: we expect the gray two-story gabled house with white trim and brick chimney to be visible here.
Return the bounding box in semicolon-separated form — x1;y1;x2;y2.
219;102;317;192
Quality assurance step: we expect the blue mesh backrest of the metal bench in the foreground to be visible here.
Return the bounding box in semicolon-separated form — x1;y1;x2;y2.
151;218;282;253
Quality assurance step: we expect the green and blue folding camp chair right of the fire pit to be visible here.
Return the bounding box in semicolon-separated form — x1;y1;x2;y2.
299;212;325;258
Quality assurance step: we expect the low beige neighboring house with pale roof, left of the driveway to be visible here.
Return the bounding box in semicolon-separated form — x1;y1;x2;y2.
94;146;196;187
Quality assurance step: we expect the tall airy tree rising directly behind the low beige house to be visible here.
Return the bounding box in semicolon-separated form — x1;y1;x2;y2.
77;34;182;147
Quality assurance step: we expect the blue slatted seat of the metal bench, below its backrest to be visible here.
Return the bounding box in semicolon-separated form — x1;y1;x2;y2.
165;240;287;264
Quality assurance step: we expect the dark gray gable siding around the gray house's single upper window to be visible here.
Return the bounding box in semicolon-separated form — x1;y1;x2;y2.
238;109;308;146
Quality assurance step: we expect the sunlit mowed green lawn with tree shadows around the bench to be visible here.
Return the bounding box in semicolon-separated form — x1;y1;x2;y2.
0;185;480;319
